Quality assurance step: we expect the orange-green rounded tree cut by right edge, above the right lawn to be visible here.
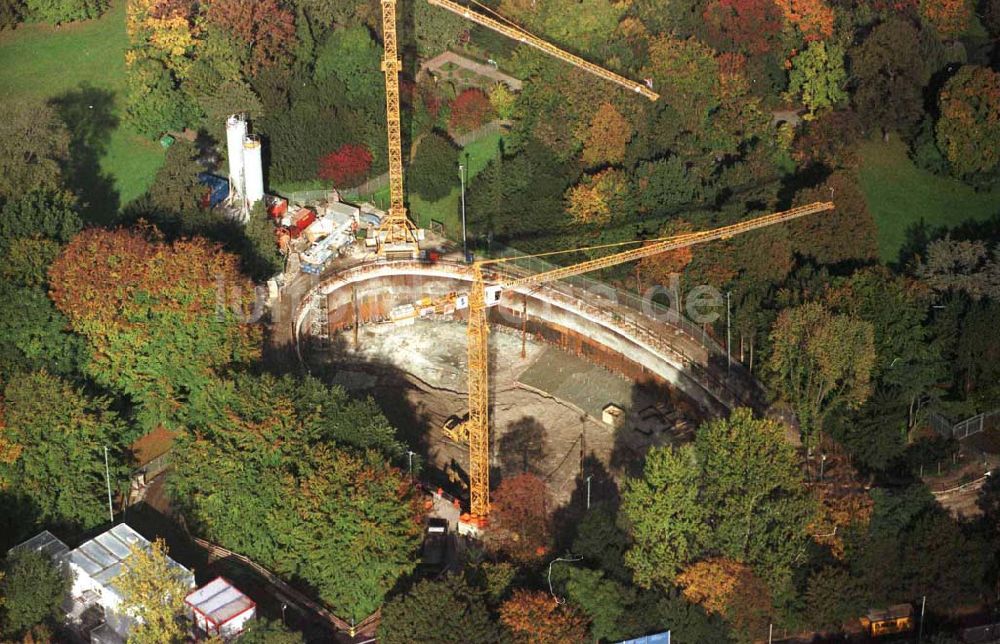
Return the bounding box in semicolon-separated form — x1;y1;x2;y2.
936;65;1000;176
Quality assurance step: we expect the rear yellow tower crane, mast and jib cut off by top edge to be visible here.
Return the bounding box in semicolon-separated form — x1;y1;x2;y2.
375;0;659;259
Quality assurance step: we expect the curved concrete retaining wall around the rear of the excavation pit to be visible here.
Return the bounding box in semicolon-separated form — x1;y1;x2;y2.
293;262;762;413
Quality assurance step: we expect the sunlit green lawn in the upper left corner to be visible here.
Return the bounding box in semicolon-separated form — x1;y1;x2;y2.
0;0;163;204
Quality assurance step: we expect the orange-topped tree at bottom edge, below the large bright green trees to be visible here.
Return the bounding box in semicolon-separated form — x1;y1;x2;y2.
677;557;772;642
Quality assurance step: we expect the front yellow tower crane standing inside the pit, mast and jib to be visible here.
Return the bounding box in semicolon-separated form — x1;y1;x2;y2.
448;202;834;517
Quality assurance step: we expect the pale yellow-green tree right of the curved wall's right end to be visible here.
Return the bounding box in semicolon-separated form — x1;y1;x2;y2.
767;303;875;442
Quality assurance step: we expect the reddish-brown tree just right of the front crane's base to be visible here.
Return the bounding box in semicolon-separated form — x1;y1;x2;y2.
491;473;552;561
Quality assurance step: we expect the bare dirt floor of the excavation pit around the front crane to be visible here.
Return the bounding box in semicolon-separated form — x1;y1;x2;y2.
313;320;698;505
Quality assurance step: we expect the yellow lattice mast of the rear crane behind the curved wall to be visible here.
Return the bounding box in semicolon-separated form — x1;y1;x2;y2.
377;0;418;257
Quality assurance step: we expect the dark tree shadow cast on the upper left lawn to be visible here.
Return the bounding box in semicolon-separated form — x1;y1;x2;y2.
51;83;120;225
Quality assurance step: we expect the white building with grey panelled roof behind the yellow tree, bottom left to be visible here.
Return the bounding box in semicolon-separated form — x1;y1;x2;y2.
68;523;195;643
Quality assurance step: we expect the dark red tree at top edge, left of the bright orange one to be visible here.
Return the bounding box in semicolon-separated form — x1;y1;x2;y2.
702;0;784;56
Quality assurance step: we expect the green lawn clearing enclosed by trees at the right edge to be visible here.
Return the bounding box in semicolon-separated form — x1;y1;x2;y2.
860;138;1000;262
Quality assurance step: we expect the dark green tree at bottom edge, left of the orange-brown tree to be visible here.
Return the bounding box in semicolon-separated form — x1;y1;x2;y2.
378;575;503;644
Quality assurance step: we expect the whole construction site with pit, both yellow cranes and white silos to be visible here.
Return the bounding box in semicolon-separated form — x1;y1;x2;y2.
213;0;833;532
